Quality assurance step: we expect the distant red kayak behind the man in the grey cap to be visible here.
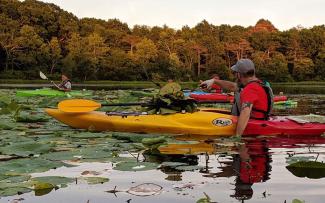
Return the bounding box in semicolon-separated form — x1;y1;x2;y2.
190;93;288;103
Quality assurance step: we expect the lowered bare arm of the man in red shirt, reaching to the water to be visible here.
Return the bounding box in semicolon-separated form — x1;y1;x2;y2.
236;102;253;136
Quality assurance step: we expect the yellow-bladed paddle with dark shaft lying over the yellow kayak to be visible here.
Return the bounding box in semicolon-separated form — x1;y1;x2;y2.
58;99;149;113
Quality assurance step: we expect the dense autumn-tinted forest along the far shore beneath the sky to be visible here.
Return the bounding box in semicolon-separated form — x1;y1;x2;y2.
0;0;325;81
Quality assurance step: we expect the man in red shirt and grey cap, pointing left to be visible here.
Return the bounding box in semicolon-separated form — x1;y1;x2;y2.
201;59;273;136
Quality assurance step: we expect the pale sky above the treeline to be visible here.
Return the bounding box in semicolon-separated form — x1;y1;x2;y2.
43;0;325;30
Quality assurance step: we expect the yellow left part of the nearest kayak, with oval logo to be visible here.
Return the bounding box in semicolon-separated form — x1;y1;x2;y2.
45;109;235;135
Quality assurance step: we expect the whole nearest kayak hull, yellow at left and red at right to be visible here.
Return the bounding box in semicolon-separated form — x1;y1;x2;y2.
45;109;325;136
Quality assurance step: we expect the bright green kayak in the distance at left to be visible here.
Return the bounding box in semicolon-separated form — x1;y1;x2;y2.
16;88;92;97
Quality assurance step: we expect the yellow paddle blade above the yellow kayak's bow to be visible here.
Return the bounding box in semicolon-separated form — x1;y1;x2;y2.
58;99;101;113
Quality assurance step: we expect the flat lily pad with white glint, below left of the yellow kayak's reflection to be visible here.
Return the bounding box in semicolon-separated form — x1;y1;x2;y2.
114;161;158;171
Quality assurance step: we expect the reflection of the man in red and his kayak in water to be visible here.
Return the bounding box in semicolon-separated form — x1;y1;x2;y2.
153;136;325;201
